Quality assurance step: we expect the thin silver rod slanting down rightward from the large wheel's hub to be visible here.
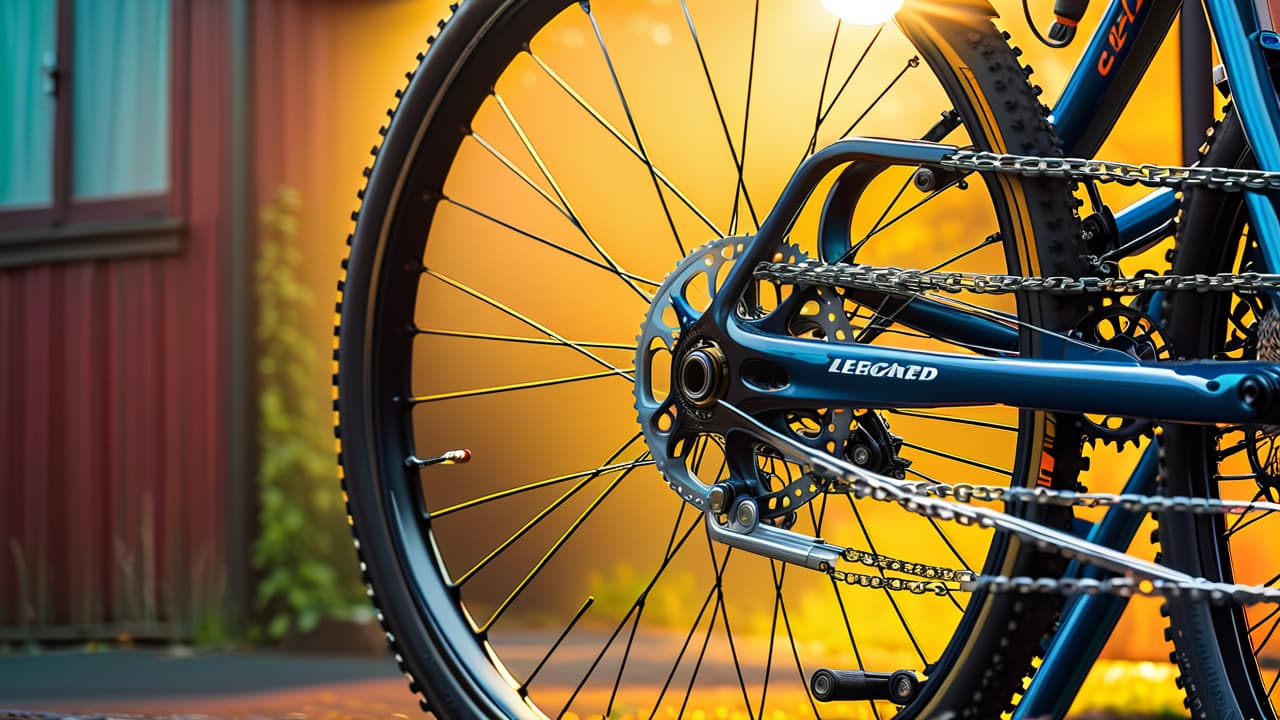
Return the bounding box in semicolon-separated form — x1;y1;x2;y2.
713;401;1233;593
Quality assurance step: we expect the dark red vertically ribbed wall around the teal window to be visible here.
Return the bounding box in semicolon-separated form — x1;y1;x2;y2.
0;3;229;638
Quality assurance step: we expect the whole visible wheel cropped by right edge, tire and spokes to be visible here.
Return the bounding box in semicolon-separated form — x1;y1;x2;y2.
1160;110;1280;717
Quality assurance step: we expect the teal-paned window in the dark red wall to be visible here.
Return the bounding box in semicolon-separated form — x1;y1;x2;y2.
0;0;182;260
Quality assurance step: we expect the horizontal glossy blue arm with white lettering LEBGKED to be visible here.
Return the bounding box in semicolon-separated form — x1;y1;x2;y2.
724;318;1280;424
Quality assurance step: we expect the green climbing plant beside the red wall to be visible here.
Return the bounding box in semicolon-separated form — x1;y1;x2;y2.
253;186;364;638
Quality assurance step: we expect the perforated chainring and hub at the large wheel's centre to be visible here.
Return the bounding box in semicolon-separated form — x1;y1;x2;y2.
635;238;855;515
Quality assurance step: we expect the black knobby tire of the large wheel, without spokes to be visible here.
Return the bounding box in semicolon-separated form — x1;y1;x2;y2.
334;0;1084;717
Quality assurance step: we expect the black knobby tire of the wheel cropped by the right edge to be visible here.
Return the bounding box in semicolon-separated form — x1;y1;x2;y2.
1158;108;1276;719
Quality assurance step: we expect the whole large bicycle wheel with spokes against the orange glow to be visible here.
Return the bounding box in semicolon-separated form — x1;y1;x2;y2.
337;0;1083;717
